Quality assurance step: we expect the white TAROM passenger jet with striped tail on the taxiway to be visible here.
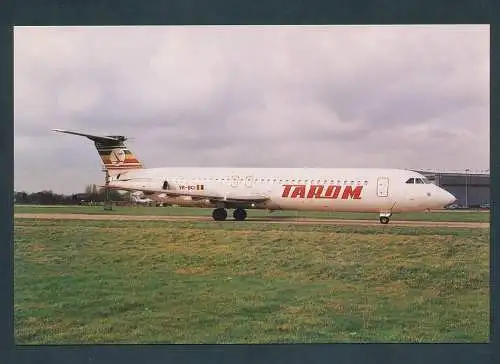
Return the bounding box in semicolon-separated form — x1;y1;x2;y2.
52;129;456;224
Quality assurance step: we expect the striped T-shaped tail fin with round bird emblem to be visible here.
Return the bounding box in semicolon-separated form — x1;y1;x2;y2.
52;129;144;174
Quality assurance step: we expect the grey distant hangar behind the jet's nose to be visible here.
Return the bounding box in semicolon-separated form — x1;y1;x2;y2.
415;171;490;208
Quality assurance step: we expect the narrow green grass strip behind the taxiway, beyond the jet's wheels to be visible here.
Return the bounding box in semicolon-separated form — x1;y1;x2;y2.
14;205;490;222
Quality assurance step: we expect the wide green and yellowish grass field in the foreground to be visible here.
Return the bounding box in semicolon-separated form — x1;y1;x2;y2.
14;218;490;344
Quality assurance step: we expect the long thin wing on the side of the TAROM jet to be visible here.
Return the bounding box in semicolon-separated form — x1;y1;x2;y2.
104;184;269;203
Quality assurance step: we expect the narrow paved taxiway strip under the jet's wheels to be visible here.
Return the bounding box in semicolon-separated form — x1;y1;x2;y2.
14;213;490;229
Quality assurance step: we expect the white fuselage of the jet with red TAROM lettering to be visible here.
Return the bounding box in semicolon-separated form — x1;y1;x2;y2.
110;167;455;213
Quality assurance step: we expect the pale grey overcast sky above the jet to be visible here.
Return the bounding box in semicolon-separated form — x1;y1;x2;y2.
14;25;489;193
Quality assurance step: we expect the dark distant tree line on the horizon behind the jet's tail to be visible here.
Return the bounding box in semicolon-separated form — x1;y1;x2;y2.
14;184;130;205
